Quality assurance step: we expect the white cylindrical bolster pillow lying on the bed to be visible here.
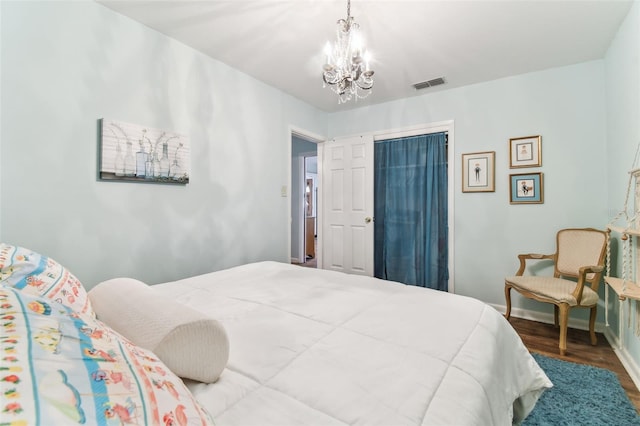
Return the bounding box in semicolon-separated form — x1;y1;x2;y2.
89;278;229;383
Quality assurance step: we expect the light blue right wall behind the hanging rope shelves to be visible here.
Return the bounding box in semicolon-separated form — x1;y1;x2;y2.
605;2;640;360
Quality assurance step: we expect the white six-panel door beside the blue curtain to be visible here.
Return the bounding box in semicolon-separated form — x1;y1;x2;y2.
319;136;373;276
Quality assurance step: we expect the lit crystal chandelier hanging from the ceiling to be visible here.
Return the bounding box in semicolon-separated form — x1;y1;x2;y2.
322;0;373;104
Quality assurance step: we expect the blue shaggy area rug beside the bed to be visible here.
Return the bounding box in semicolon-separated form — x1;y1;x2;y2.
522;354;640;426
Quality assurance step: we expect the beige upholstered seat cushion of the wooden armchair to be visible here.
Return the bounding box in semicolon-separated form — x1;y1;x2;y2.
505;276;599;306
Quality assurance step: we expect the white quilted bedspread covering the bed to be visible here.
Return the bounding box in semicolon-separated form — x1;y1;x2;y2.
154;262;551;426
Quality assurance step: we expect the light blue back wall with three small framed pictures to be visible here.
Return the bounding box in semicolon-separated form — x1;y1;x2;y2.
329;61;607;312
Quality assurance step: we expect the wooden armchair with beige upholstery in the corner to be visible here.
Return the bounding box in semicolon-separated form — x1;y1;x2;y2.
504;228;607;355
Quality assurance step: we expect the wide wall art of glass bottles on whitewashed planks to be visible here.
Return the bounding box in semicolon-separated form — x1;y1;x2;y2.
99;118;191;184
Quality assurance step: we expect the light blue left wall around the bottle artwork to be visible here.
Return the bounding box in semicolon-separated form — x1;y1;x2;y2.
0;1;326;287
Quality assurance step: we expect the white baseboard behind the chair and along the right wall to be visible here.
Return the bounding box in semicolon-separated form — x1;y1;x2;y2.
491;304;640;390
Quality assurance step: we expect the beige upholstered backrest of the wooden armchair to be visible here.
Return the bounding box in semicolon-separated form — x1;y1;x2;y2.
555;228;607;285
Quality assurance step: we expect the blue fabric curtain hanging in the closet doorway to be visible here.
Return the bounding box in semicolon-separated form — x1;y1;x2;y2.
374;133;449;291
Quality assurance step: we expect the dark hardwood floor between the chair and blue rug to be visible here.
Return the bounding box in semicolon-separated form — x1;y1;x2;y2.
509;317;640;413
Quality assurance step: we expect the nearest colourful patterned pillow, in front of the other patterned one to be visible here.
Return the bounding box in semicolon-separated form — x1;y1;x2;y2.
0;285;213;425
